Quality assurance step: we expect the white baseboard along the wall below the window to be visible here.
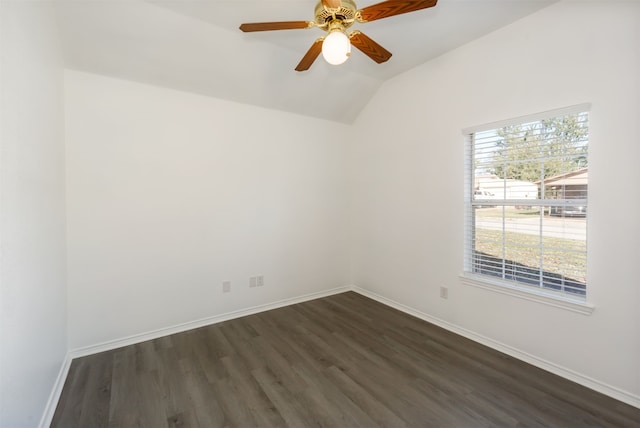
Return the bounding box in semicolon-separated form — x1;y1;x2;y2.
351;285;640;409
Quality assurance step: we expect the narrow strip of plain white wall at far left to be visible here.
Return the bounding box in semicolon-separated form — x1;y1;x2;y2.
0;1;67;427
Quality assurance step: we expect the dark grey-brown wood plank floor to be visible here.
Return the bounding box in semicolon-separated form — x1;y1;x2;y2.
52;292;640;428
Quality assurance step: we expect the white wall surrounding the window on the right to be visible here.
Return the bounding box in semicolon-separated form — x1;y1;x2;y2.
351;1;640;405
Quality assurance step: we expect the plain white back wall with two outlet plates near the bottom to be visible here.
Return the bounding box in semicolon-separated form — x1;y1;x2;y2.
65;71;349;349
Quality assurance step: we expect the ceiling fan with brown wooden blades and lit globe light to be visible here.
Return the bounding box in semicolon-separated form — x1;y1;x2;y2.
240;0;438;71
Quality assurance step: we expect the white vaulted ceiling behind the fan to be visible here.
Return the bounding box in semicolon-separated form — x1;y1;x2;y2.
56;0;557;123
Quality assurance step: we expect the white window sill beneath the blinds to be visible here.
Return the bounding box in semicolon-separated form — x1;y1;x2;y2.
460;272;595;315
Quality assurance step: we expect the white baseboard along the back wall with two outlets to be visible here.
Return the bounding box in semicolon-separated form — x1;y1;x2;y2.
69;286;351;359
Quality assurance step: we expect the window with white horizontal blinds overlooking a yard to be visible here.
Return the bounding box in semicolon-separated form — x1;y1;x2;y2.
464;105;589;301
